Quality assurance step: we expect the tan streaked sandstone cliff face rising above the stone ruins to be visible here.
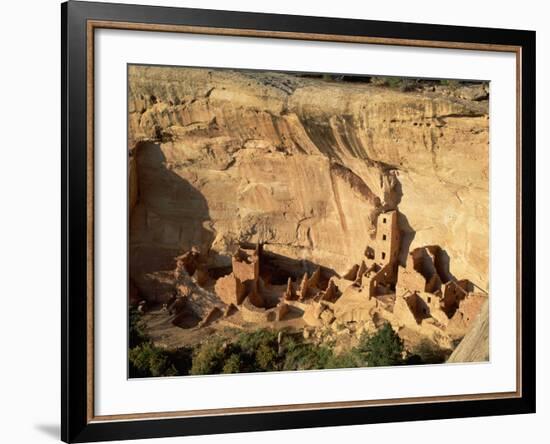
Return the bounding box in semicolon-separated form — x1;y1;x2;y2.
129;66;489;296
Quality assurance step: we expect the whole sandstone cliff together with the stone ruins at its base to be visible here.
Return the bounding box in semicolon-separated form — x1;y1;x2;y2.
128;65;489;358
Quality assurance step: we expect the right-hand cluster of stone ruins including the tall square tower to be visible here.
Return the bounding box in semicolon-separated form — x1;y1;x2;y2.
326;211;487;348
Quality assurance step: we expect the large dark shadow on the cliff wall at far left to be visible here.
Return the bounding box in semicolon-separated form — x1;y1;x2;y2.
128;142;214;299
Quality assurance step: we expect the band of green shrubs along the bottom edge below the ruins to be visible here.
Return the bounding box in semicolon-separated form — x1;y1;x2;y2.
128;311;447;378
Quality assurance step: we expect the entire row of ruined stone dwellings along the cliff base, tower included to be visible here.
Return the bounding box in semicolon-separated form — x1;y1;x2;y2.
141;210;487;348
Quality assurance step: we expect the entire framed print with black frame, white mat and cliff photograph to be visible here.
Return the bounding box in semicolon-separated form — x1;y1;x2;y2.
61;1;535;442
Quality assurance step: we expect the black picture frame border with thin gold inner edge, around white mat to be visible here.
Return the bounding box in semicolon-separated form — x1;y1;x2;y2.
61;1;536;442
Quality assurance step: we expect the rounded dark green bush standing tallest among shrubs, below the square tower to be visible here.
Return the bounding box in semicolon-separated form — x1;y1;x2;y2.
357;323;405;367
